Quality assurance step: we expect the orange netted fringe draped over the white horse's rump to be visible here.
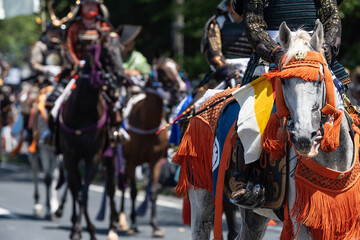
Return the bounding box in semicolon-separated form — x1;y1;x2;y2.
173;86;239;196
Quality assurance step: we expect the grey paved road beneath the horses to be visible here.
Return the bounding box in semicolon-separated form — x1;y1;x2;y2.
0;164;281;240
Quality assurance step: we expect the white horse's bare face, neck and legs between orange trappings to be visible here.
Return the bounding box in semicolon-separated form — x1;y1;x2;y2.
188;21;359;240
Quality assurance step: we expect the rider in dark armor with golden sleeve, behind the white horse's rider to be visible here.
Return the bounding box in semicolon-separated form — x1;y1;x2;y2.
201;0;253;89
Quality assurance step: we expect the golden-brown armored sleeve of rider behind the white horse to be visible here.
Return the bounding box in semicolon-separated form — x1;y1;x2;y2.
202;17;226;70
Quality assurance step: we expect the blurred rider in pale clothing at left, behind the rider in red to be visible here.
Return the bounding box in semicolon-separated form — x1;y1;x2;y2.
30;21;65;85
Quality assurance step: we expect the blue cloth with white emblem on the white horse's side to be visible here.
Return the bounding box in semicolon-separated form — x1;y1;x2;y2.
212;102;240;201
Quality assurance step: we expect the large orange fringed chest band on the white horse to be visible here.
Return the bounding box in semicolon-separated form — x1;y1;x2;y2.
291;134;360;240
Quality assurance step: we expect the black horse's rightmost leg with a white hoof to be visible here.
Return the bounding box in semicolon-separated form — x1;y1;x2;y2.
104;157;119;240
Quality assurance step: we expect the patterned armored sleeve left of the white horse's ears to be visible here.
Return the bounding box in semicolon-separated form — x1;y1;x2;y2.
244;0;279;62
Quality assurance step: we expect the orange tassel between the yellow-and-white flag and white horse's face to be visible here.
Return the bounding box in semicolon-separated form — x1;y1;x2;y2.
263;113;288;161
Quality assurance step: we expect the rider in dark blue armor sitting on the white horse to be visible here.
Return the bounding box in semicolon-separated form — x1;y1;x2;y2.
232;0;350;204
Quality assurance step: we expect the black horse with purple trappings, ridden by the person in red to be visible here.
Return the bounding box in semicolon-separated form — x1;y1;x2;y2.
59;30;123;240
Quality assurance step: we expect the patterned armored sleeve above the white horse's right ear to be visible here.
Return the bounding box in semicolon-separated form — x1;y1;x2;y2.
317;0;341;57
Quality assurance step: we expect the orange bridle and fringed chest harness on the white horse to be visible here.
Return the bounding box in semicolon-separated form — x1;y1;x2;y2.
263;52;360;240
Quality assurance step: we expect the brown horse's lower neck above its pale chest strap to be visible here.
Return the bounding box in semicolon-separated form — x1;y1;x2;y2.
129;93;163;130
